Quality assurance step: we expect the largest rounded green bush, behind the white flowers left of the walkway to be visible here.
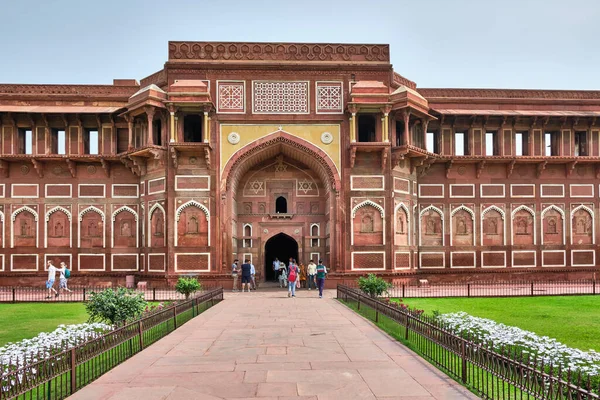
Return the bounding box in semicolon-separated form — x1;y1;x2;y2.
85;288;148;325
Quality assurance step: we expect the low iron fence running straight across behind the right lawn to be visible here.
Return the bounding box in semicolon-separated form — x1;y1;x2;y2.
348;279;600;298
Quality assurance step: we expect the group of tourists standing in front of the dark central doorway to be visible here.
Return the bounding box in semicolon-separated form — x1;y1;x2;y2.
231;257;327;298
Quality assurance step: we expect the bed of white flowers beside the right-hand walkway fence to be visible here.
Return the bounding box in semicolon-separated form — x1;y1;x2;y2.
437;312;600;377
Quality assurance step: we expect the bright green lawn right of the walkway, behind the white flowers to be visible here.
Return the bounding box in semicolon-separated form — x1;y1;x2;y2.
404;296;600;351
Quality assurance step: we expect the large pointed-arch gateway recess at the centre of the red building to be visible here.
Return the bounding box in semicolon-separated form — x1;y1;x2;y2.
221;130;339;280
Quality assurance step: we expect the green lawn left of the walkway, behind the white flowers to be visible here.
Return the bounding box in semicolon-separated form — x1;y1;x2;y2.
0;303;88;346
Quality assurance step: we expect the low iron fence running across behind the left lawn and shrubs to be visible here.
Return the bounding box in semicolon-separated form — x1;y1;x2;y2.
0;285;216;303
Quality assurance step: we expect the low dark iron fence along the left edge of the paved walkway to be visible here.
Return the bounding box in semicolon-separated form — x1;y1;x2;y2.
0;288;223;400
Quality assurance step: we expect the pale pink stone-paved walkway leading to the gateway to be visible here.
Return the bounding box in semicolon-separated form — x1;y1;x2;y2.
71;291;476;400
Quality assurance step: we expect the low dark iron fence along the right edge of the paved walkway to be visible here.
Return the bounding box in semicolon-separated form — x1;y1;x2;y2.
337;285;600;400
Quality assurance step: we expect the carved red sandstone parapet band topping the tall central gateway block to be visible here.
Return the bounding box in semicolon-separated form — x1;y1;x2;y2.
169;42;390;63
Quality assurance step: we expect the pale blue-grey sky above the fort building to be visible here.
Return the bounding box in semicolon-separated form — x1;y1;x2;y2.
0;0;600;90
